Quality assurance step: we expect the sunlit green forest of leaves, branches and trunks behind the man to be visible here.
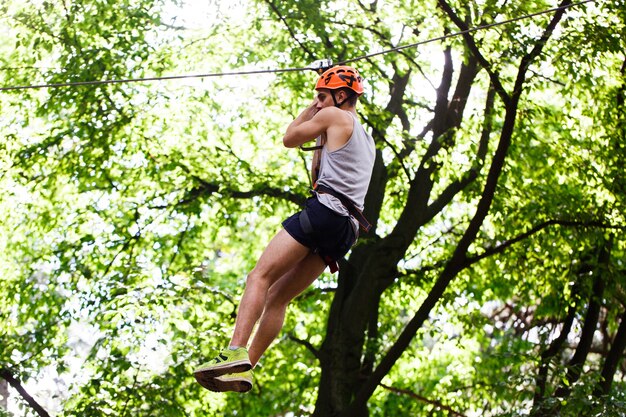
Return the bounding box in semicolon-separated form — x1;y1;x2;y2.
0;0;626;416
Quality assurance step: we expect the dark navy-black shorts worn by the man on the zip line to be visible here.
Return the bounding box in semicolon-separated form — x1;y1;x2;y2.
283;197;356;263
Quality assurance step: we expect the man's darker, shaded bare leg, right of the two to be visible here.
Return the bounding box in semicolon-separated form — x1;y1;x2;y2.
248;253;326;367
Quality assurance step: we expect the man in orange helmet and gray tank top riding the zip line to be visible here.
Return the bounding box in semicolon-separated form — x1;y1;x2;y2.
194;66;375;392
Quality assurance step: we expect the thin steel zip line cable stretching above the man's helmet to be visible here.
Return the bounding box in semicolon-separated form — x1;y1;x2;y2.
0;0;597;92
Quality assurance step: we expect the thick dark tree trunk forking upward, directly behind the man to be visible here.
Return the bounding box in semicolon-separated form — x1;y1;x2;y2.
314;45;478;417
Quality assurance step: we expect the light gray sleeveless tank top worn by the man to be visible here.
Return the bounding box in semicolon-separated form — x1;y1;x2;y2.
317;113;376;216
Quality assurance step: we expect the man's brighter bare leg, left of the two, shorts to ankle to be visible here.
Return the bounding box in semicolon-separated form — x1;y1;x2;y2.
230;229;310;347
